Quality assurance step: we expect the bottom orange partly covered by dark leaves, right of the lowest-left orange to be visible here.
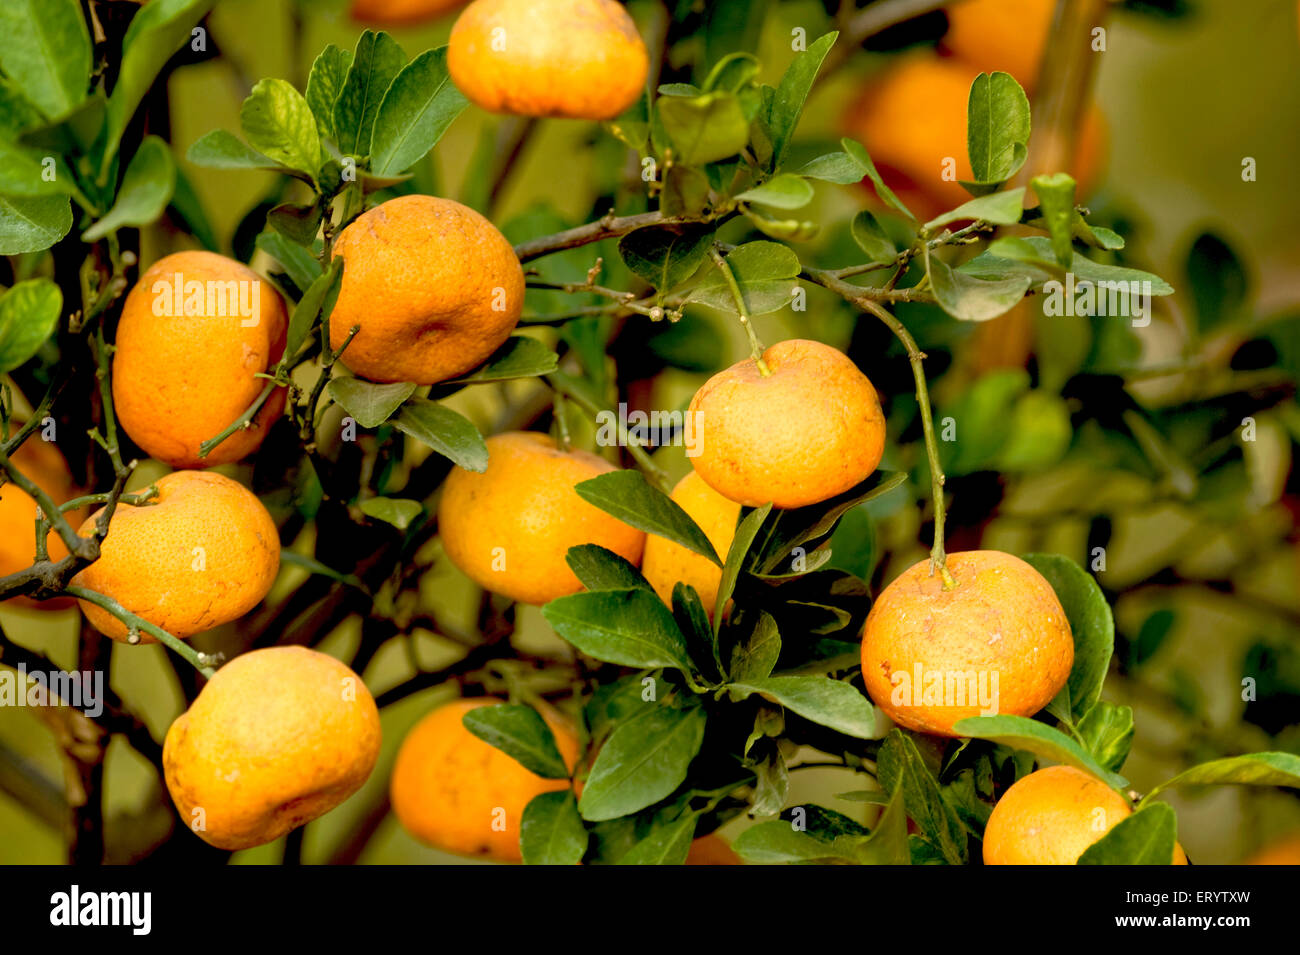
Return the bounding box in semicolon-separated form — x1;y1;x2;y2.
389;698;579;863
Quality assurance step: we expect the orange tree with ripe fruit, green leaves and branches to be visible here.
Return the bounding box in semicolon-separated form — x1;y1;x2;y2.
0;0;1300;864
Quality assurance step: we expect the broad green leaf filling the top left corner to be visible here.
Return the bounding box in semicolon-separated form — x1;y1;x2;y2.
0;0;91;120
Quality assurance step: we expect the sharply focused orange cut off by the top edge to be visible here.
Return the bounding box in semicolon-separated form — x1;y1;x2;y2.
447;0;650;120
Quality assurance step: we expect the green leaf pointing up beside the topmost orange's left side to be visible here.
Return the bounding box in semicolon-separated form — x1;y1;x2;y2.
371;47;469;175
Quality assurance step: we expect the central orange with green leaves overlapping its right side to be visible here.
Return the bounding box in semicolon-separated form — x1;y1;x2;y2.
438;431;646;604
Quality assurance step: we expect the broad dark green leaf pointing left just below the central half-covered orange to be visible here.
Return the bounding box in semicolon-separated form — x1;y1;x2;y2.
542;587;690;673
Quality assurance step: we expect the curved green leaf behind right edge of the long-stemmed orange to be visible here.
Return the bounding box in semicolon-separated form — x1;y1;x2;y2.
1022;554;1115;717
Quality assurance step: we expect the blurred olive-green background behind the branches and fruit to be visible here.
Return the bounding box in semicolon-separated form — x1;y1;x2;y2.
0;0;1300;863
